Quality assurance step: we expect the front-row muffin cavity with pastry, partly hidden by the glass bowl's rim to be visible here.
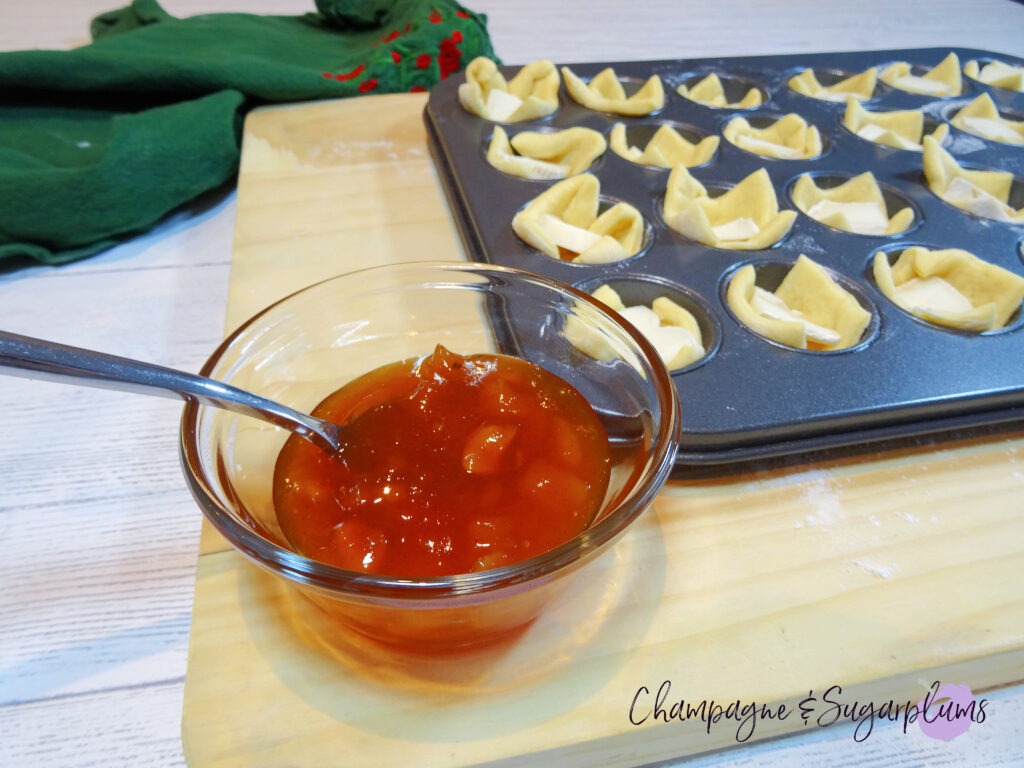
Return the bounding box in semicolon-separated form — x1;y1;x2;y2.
570;274;721;373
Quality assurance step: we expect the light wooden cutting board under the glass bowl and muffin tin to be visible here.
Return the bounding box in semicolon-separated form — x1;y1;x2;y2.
182;95;1024;768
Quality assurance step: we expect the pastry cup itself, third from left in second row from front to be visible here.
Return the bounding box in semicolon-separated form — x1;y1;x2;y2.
792;171;913;234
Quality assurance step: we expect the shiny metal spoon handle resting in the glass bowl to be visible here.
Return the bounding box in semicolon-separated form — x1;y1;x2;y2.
0;331;341;454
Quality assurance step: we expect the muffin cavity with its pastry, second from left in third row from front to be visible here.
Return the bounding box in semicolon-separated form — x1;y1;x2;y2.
608;121;719;168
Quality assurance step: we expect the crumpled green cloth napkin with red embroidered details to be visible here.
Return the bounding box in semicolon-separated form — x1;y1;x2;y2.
0;0;495;264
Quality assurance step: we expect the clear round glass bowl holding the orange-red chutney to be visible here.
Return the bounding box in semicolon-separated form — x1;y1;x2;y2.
180;262;680;653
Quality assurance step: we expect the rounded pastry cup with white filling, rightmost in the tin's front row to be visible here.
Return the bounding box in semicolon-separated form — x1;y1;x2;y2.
872;246;1024;333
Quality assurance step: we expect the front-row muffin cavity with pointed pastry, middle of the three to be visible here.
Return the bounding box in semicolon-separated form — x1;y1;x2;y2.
722;259;879;352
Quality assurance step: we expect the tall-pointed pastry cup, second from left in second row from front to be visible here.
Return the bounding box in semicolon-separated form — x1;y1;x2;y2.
662;165;797;251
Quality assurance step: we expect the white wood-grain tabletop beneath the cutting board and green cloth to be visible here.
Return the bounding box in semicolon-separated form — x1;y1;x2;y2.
0;0;1024;768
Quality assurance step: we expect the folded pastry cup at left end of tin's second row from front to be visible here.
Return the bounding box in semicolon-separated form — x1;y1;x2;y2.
512;173;644;264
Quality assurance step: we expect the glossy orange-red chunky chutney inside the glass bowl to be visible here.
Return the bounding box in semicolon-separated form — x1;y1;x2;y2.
273;345;611;578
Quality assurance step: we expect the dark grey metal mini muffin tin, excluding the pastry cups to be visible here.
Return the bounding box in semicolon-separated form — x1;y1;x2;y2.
424;48;1024;464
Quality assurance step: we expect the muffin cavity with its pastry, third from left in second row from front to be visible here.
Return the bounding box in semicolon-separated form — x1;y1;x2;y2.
788;171;921;237
